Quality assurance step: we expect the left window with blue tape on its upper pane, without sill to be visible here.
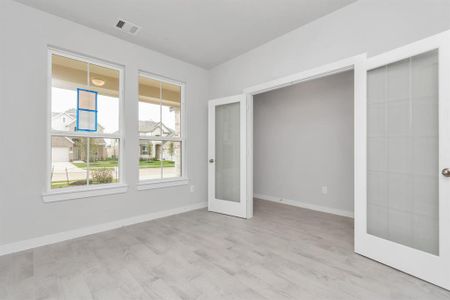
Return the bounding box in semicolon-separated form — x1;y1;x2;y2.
49;51;122;191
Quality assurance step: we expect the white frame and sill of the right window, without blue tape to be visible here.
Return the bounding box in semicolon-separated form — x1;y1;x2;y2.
136;70;189;191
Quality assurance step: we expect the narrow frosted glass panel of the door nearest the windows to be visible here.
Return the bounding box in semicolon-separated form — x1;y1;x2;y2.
215;102;241;202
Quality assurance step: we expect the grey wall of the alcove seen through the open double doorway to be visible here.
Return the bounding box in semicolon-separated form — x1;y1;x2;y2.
253;71;354;215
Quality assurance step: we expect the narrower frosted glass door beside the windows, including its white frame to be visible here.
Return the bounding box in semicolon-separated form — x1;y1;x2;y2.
208;95;253;218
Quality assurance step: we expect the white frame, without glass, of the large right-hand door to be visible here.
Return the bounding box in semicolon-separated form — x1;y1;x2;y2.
355;31;450;289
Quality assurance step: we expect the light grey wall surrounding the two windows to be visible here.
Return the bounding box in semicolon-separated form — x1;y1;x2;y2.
0;0;208;245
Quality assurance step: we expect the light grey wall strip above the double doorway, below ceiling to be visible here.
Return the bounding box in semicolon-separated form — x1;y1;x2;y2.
210;0;450;98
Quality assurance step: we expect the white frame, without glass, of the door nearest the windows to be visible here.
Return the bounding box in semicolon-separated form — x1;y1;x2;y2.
208;94;253;219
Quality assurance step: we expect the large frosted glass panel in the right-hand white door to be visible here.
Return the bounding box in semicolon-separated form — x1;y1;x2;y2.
367;50;439;255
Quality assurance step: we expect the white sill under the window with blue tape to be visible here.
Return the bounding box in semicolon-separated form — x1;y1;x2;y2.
42;184;128;203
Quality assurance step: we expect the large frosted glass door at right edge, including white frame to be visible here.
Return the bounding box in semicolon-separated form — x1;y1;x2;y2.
355;31;450;289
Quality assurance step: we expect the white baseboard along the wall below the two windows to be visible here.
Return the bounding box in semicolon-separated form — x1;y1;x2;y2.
0;202;208;256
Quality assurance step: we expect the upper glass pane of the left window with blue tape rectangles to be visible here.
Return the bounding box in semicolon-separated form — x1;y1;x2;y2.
51;54;120;134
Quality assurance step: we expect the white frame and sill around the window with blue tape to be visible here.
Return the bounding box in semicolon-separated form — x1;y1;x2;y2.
42;47;128;202
